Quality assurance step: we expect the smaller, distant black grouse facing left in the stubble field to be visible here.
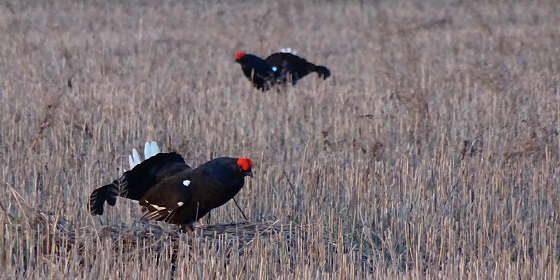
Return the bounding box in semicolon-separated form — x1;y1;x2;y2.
235;49;331;90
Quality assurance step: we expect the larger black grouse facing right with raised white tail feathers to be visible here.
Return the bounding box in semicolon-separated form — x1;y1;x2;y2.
89;142;253;230
